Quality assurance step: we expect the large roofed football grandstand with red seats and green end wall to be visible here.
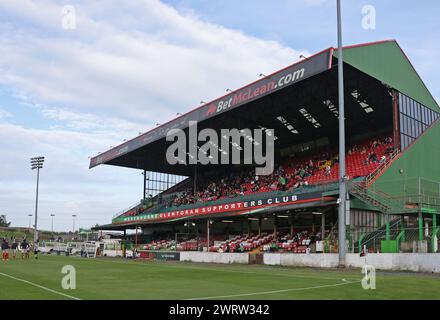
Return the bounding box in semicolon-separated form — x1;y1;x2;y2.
90;40;440;252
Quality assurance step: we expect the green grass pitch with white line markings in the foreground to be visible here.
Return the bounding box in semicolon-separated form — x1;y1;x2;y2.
0;255;440;300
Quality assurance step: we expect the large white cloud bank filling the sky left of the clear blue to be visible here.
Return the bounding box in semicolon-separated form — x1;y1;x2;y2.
0;0;309;228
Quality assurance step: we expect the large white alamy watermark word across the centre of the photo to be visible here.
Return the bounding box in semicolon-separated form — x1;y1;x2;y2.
166;121;275;175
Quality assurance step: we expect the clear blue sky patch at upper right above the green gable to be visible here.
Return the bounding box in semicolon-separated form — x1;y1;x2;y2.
164;0;440;100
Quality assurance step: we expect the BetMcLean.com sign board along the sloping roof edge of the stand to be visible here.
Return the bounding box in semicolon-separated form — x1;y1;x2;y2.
90;49;331;168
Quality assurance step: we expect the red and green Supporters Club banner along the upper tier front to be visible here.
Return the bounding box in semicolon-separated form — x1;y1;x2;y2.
113;192;325;223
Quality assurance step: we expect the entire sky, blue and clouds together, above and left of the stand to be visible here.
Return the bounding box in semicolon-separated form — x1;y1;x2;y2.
0;0;440;230
